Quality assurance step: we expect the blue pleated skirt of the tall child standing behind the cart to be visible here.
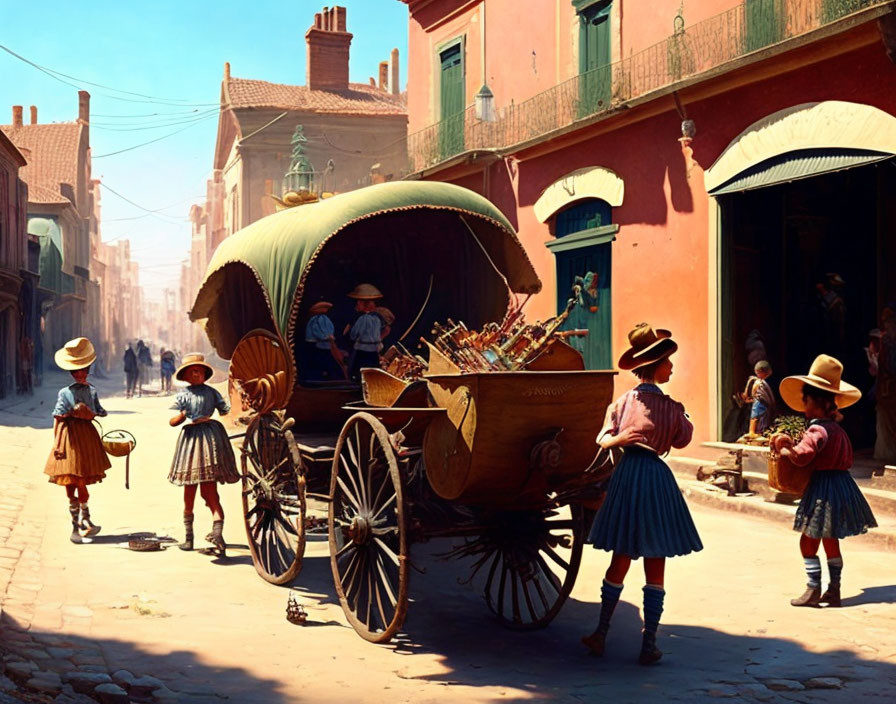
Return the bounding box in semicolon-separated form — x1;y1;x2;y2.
588;447;703;558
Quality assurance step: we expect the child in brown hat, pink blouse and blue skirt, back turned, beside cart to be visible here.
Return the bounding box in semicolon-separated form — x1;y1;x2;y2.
582;323;703;665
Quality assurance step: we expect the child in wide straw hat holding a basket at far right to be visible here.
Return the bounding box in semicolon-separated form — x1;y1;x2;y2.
772;354;877;606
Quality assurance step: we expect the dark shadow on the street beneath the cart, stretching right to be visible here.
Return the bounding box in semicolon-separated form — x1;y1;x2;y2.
284;541;896;702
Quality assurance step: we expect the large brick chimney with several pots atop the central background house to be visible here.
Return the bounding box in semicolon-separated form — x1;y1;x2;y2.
305;5;352;90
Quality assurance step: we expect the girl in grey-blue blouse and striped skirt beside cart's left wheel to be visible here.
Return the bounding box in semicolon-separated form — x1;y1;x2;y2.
168;354;240;555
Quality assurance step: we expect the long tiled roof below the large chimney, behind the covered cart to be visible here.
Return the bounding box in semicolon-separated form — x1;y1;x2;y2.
227;78;408;115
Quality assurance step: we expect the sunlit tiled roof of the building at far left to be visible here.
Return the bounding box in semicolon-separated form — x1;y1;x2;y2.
0;122;82;198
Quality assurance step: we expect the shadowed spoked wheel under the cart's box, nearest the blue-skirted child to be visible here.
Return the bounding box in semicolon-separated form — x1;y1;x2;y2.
477;505;586;630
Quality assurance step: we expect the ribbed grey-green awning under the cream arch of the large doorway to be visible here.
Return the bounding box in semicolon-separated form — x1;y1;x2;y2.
709;148;893;196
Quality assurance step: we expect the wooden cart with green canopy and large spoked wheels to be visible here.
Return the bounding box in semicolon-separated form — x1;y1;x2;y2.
191;182;615;642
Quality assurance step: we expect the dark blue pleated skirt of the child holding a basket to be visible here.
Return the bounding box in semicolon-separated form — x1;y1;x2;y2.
793;470;877;538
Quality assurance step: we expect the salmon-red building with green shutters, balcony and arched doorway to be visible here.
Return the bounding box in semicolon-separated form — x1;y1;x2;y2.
402;0;896;460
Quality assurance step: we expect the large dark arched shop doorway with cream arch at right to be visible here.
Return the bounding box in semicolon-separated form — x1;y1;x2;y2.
706;101;896;456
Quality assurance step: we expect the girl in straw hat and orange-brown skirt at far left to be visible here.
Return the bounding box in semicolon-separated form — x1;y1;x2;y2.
44;337;111;543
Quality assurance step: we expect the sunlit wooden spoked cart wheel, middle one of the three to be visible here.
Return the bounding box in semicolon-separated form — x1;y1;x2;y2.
329;413;408;643
